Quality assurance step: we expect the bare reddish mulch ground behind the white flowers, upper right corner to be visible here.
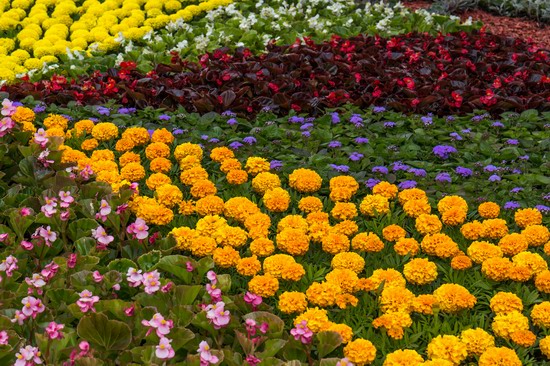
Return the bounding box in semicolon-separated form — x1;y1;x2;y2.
403;0;550;49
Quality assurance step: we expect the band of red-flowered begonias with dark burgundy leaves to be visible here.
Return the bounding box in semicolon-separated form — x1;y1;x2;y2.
3;31;550;116
